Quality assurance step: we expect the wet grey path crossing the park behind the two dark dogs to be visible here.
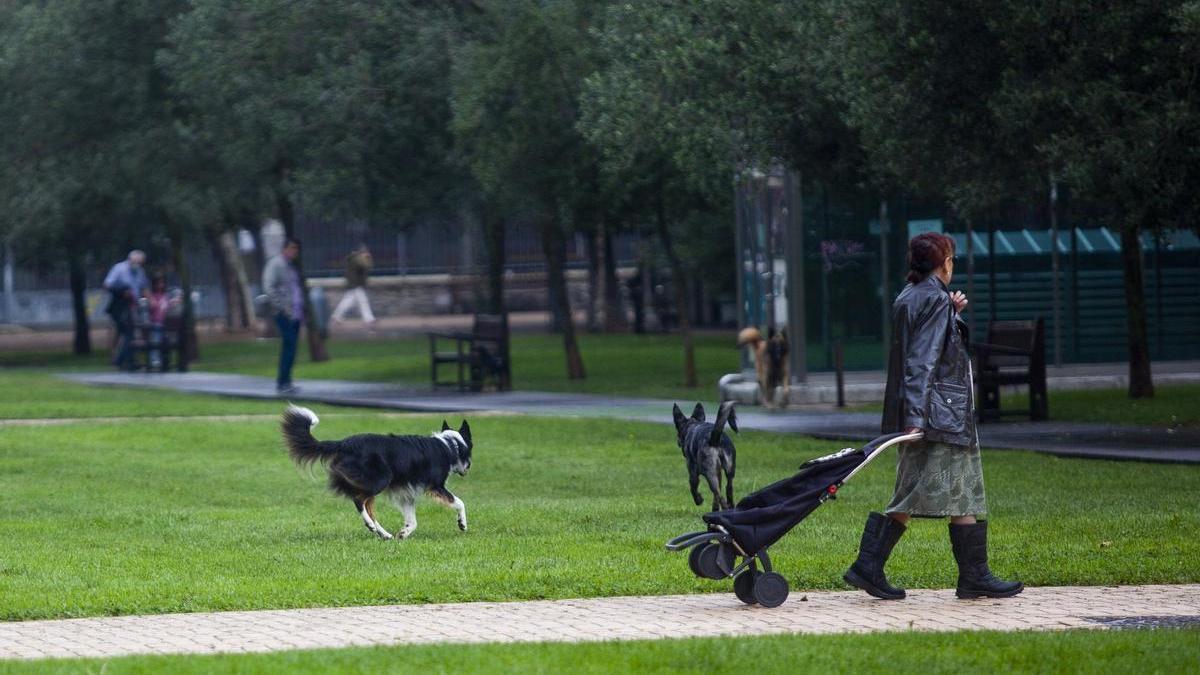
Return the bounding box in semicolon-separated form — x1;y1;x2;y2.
62;372;1200;464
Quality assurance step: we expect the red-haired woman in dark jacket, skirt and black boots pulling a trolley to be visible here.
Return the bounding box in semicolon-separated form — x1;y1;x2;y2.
844;232;1025;599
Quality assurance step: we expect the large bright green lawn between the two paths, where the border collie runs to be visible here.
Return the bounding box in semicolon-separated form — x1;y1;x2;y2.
0;386;1200;620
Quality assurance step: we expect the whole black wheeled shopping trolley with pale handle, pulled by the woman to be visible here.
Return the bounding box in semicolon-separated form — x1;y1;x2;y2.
667;432;923;607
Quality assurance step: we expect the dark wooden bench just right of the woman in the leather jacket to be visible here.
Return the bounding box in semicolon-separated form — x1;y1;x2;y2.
972;317;1050;422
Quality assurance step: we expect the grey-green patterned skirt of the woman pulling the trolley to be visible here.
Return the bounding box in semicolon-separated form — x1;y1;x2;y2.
887;442;988;518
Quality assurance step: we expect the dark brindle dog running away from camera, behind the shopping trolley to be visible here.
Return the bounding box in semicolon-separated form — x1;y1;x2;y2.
671;401;738;510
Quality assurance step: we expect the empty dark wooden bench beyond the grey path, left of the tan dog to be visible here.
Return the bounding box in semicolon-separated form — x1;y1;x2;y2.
428;313;512;392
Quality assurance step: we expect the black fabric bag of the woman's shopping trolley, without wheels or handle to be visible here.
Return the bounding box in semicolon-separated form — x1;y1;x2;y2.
703;446;868;555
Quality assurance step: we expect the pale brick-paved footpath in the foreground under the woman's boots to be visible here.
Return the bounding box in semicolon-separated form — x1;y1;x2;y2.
0;585;1200;658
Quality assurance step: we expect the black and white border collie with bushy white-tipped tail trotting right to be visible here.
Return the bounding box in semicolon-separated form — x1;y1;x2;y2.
280;406;474;539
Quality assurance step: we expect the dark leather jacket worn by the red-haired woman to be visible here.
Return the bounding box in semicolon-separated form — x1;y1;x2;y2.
883;274;977;446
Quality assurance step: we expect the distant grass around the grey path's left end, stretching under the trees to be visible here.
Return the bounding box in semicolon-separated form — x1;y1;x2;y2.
0;326;738;419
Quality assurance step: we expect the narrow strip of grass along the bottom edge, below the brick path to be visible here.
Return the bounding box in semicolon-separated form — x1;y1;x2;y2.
0;629;1200;675
